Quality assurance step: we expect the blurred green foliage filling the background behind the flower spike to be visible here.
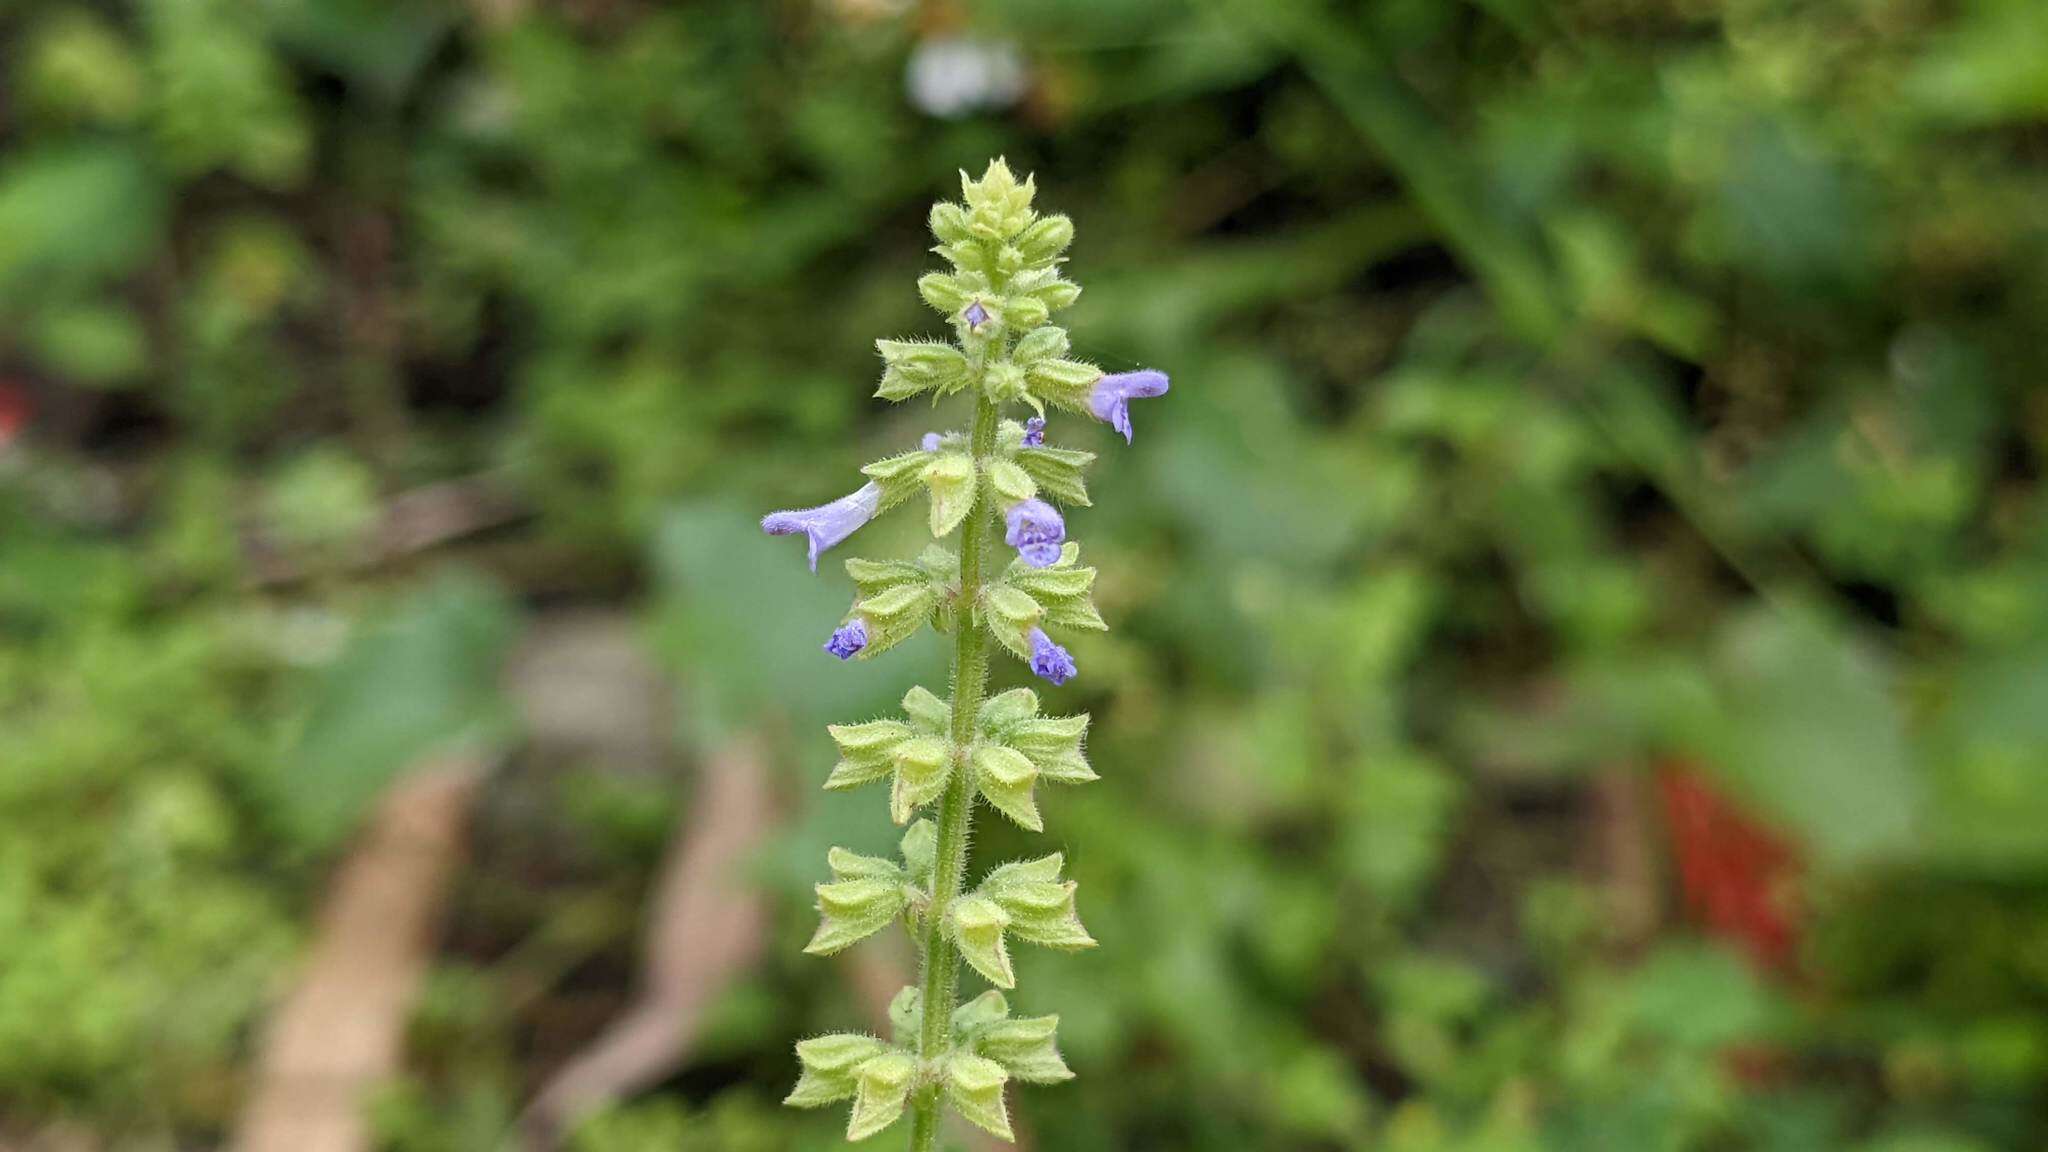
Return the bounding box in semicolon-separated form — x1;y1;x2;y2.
0;0;2048;1152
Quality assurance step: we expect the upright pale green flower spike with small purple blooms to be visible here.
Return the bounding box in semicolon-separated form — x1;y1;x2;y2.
762;160;1167;1152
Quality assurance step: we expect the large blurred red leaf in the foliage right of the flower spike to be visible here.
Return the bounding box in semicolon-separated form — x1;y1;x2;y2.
1657;763;1800;972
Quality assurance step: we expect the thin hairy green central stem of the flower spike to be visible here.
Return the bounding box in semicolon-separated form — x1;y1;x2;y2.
909;396;995;1152
